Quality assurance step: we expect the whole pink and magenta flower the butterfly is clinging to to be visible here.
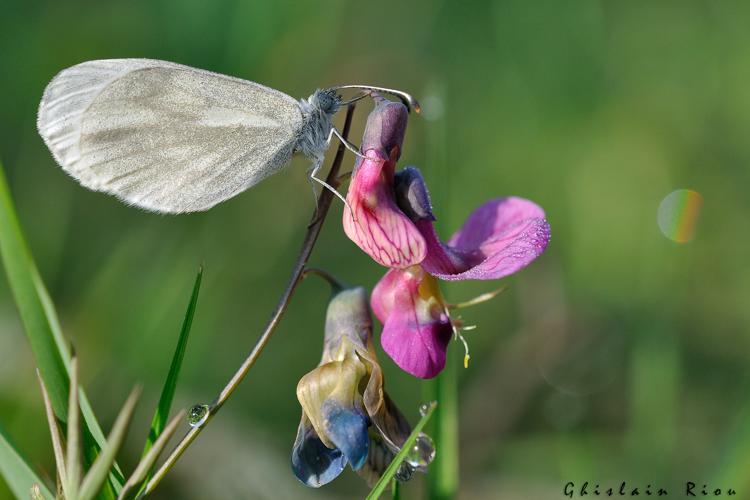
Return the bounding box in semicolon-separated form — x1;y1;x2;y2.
344;96;550;378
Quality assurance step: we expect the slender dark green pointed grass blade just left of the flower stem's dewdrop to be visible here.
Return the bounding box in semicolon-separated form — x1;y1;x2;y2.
142;266;203;456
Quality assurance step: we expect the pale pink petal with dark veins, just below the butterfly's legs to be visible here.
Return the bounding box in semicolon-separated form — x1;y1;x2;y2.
343;150;427;268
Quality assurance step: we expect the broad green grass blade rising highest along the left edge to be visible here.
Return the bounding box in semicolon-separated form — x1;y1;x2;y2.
0;163;123;498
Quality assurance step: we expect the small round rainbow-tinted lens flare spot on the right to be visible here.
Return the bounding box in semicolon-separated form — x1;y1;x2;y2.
656;189;703;243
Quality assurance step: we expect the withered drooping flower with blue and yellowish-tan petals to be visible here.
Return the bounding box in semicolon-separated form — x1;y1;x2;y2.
292;288;411;487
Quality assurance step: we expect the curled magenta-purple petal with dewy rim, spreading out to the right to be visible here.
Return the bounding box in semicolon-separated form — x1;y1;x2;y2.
420;197;550;281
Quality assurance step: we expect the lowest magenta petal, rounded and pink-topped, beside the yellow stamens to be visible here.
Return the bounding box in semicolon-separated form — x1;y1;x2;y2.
371;266;453;378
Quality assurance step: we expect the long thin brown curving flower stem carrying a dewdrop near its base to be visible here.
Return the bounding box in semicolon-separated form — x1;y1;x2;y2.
144;104;355;494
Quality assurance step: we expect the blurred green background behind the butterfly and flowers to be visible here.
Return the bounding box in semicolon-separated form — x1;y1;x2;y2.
0;0;750;499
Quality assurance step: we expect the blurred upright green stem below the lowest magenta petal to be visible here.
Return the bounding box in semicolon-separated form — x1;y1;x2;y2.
426;356;460;500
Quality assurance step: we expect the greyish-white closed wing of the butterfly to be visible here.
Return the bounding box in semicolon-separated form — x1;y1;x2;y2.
37;59;302;213
